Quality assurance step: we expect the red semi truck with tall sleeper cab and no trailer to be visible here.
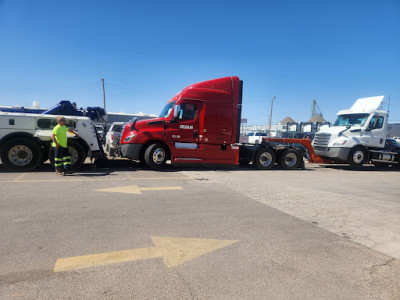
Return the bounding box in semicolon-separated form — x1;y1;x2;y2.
120;76;305;170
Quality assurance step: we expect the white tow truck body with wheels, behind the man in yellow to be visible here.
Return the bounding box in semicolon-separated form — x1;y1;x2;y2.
0;112;104;172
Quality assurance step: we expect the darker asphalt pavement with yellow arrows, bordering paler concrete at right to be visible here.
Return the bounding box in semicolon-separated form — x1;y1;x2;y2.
0;165;400;299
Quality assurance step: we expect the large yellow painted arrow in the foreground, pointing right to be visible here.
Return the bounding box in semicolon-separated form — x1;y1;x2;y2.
54;236;237;272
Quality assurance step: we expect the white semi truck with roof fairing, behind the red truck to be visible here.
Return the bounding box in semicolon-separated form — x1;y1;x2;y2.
312;96;400;167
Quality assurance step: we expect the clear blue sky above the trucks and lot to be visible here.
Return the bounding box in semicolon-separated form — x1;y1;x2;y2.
0;0;400;124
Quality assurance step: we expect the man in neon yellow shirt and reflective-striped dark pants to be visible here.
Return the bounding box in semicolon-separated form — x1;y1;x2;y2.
51;117;78;176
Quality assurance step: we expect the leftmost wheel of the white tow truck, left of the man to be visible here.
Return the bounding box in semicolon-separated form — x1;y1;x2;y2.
1;138;42;172
